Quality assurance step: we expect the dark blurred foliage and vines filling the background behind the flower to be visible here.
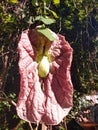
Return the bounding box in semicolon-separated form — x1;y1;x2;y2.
0;0;98;130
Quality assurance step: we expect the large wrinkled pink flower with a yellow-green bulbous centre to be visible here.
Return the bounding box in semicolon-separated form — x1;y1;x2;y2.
16;29;73;125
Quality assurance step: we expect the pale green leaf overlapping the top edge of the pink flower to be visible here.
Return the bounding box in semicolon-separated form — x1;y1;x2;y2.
37;28;56;41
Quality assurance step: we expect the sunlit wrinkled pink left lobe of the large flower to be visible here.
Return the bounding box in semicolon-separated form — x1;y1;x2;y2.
16;31;45;122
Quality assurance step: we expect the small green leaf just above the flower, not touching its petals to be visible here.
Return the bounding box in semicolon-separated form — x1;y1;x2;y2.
35;16;55;25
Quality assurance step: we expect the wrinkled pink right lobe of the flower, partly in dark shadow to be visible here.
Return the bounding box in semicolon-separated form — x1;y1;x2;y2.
43;35;73;125
